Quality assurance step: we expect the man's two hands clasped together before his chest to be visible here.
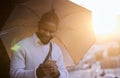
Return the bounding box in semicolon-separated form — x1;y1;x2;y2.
36;60;60;78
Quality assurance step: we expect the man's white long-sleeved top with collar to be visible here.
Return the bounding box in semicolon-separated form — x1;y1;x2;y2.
10;34;68;78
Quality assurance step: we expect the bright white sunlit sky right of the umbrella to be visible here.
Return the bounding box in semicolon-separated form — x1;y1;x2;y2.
70;0;120;40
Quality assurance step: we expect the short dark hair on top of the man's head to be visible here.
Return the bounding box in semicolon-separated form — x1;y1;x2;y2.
40;9;59;25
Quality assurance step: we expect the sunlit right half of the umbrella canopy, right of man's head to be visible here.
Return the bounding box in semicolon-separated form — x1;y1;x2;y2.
54;0;95;64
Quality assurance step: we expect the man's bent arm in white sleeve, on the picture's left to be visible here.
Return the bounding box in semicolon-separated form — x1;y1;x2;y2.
10;45;36;78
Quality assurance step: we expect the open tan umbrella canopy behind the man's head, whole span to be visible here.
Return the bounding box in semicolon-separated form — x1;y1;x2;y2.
1;0;95;64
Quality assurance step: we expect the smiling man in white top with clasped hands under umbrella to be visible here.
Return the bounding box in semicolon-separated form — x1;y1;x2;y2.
10;10;68;78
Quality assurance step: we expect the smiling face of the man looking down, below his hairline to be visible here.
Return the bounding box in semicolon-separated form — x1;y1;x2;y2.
37;22;57;44
